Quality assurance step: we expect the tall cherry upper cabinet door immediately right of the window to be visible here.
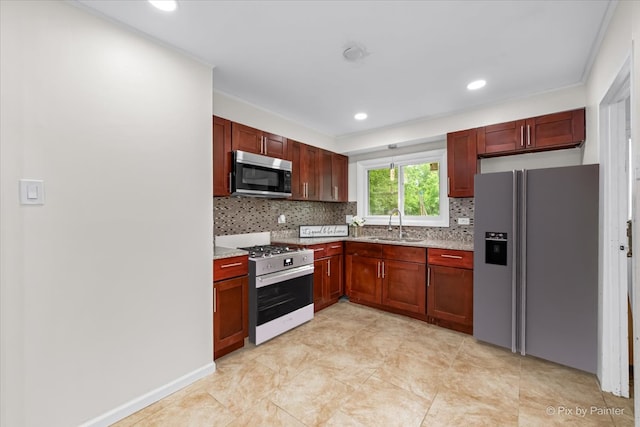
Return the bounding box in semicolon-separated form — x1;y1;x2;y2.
447;129;478;197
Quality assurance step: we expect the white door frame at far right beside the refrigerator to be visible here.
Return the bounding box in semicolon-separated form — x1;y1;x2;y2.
598;56;637;397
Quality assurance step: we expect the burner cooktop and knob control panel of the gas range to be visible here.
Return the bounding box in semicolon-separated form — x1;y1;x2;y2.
238;245;313;276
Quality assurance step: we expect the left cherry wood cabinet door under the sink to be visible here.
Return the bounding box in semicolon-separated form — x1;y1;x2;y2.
346;255;382;304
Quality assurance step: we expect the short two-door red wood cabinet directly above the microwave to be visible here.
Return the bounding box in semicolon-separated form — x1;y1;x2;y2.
231;122;290;160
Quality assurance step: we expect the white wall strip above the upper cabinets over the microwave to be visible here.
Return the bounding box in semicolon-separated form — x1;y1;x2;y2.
213;91;339;152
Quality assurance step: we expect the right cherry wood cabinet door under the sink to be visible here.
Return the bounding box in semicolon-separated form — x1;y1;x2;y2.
382;259;427;314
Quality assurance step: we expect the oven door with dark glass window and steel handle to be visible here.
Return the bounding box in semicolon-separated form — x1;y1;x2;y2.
256;264;313;326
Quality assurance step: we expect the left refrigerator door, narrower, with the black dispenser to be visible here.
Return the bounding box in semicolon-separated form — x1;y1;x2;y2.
473;172;518;351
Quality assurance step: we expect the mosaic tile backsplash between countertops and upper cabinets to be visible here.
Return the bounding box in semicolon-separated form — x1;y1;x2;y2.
213;197;473;242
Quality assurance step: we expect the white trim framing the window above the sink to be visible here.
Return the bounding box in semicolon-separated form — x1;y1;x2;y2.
356;149;449;227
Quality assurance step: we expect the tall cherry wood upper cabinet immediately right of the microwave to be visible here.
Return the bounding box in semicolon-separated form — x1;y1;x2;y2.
289;140;320;200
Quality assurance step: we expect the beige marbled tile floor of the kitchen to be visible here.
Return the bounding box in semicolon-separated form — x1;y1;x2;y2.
114;300;633;427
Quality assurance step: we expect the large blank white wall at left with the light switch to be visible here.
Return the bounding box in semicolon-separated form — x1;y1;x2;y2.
0;1;214;427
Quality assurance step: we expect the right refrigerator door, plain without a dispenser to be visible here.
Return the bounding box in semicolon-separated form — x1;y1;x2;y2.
521;165;598;373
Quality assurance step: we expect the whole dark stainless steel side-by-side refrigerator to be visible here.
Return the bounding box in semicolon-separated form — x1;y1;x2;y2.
473;165;599;373
